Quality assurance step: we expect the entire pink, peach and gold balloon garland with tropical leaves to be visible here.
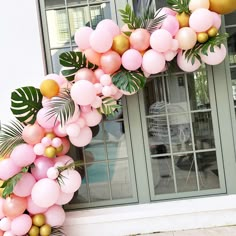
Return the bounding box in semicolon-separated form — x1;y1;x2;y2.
0;0;236;236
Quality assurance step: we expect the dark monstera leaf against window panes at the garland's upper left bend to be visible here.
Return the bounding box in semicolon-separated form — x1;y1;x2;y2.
59;51;98;81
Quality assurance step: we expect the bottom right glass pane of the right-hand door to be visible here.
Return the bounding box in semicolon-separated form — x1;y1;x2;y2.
197;152;220;190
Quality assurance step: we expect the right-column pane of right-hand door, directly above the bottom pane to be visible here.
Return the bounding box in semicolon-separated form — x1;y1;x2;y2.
192;112;215;150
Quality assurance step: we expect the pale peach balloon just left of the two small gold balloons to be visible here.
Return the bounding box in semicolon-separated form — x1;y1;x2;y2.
175;27;197;50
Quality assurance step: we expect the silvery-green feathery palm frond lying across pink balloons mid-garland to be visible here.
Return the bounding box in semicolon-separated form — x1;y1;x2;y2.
46;89;76;125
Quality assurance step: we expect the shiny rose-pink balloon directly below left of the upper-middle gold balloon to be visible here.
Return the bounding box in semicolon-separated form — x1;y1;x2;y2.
101;50;121;74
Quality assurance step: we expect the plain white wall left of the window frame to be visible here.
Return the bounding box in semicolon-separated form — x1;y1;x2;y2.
0;0;44;123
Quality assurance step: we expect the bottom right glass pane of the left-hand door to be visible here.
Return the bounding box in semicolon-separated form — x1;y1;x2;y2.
109;161;132;199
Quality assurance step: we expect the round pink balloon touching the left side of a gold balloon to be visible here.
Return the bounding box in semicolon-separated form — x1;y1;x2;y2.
89;29;113;53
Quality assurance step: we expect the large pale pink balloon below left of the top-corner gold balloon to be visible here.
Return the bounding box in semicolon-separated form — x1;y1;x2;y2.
189;8;213;32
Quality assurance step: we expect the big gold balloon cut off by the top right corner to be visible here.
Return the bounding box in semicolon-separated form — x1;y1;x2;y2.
209;0;236;15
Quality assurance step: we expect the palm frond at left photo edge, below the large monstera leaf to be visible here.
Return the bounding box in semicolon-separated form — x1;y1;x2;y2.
0;121;24;157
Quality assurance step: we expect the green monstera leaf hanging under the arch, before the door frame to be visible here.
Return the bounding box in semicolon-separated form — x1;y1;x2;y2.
112;68;146;93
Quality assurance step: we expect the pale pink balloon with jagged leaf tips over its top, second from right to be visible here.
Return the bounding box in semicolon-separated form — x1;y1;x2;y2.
177;51;201;72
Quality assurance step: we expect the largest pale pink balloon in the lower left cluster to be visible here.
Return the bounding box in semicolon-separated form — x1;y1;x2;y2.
31;178;60;207
